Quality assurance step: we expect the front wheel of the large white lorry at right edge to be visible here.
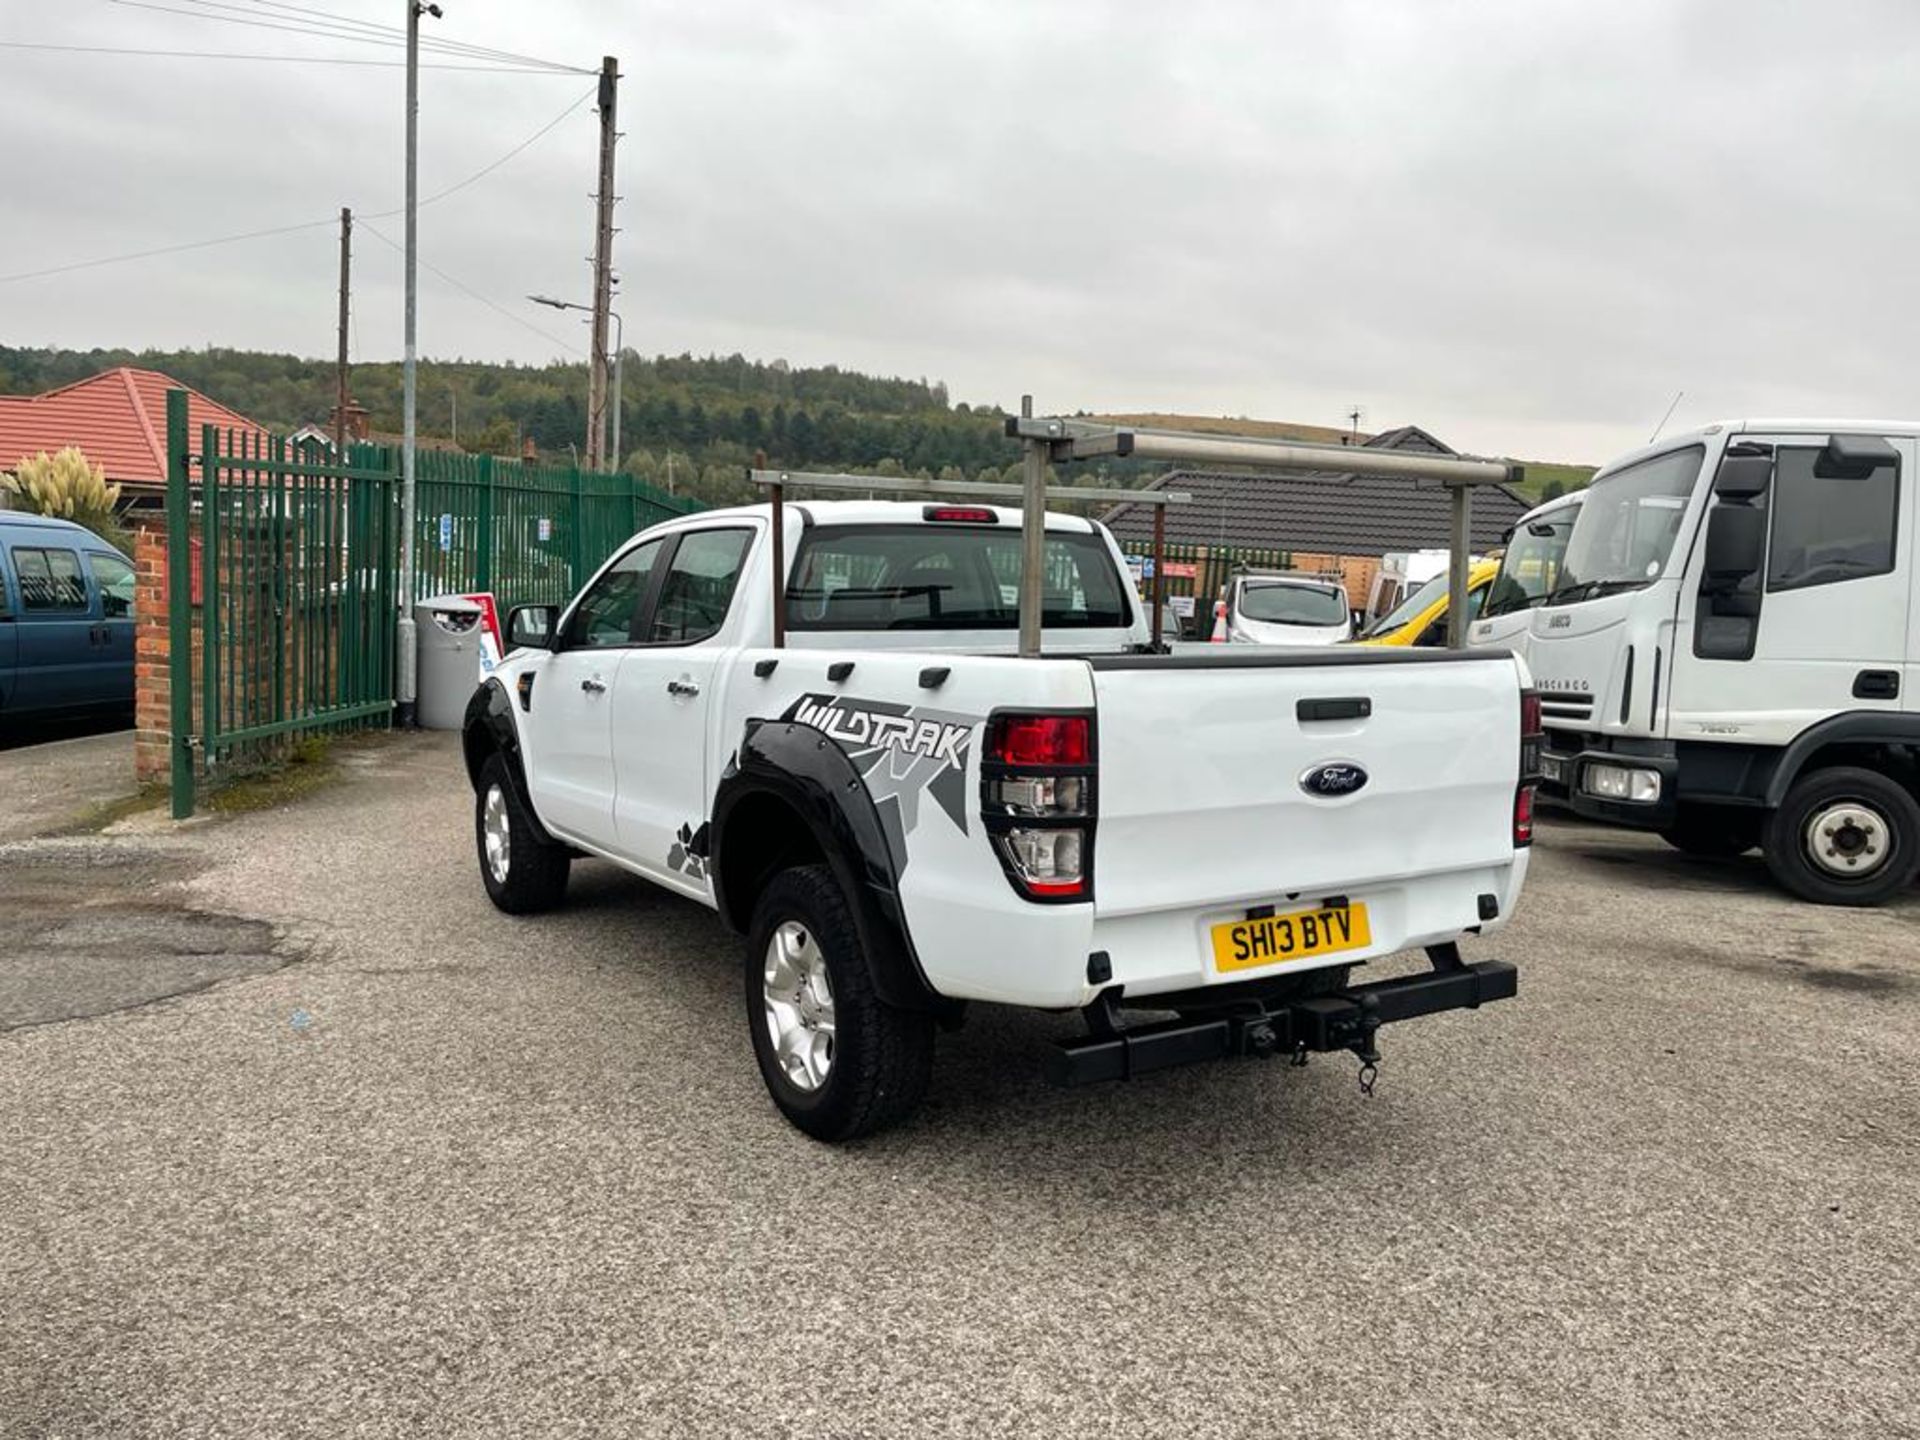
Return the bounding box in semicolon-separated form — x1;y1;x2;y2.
1766;766;1920;904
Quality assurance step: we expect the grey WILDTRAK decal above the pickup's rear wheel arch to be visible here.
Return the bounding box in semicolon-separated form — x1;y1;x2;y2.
783;695;985;874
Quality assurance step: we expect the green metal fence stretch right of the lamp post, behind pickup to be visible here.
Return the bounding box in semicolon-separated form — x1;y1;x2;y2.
413;451;699;607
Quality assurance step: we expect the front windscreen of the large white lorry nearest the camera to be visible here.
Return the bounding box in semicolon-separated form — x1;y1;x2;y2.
1546;445;1705;605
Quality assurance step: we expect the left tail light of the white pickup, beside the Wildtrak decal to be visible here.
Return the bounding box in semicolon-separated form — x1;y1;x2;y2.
981;714;1094;902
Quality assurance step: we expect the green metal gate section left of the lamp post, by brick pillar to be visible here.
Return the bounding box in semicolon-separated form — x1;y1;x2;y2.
167;390;399;818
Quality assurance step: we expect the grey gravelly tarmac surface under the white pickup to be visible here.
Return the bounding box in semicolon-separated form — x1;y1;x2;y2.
0;735;1920;1438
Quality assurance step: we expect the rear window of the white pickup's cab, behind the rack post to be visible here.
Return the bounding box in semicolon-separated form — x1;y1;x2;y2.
787;522;1133;630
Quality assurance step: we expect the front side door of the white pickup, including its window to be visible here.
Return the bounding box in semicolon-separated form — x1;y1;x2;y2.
522;540;668;851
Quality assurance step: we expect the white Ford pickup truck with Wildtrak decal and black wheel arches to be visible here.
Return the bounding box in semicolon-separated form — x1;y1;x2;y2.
465;501;1538;1140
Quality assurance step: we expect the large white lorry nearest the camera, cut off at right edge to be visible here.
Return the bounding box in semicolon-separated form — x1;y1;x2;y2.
1526;420;1920;904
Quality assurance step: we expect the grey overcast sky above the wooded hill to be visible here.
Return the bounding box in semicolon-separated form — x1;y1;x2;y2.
0;0;1920;461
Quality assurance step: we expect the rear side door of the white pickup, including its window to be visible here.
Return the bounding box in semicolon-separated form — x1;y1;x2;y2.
612;526;755;899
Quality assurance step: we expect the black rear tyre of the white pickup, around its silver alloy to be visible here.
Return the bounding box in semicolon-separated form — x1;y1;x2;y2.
745;866;933;1142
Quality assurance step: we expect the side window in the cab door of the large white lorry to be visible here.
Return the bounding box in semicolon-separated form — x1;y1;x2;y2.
1766;445;1901;591
